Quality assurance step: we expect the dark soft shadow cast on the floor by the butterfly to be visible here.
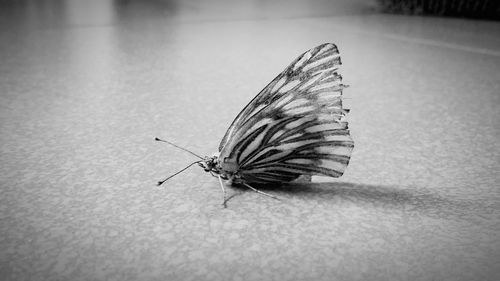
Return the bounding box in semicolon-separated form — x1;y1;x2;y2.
231;182;477;218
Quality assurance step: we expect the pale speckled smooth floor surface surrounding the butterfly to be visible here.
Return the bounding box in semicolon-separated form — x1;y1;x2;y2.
0;0;500;281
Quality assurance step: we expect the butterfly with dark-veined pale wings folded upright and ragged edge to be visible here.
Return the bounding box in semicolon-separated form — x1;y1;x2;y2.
156;43;354;206
